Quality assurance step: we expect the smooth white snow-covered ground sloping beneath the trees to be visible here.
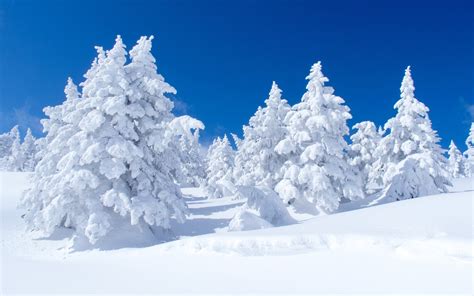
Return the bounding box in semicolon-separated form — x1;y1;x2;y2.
0;173;474;295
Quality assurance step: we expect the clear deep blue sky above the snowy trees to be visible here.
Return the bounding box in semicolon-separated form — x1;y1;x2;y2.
0;0;474;149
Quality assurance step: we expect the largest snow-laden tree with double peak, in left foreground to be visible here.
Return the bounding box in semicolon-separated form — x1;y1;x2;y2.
23;36;191;243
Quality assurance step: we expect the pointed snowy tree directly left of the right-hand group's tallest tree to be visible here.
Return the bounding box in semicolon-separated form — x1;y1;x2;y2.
234;82;290;189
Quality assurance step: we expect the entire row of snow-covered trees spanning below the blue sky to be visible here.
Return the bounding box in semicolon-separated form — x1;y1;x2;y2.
4;36;474;243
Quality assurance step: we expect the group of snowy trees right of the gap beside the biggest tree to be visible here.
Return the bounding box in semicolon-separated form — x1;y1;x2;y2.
205;62;474;212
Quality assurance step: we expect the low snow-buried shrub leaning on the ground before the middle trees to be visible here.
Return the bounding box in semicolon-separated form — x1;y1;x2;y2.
228;186;295;231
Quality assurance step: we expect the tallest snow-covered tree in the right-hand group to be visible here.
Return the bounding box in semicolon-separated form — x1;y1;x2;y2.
275;62;363;212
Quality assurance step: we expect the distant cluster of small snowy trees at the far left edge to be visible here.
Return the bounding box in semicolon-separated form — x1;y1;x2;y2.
0;126;41;172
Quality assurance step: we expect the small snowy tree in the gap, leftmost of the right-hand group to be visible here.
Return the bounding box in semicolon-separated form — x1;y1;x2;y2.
204;135;235;198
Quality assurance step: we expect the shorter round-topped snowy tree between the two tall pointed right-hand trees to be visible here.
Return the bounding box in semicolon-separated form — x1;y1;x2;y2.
349;121;382;194
